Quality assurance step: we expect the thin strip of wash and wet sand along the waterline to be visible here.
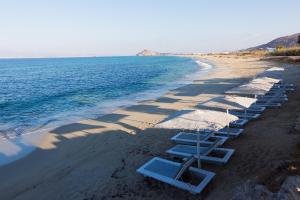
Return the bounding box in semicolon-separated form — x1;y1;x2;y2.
0;58;215;166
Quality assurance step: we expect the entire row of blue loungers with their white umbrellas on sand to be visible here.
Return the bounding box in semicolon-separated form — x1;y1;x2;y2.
137;67;294;193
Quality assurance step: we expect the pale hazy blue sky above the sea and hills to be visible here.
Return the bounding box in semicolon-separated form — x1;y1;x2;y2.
0;0;300;57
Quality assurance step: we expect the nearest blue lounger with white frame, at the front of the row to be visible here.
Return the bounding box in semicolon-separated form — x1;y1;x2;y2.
137;157;215;194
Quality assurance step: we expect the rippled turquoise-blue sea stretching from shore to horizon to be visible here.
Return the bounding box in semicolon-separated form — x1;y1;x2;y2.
0;57;210;138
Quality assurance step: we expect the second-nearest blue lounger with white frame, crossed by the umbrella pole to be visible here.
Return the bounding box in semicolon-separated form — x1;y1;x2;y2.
166;144;234;165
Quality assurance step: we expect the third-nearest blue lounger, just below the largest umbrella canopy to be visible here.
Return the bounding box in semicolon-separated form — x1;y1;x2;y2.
171;132;228;146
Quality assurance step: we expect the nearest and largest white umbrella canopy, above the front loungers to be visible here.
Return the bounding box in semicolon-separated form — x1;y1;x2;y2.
155;110;239;131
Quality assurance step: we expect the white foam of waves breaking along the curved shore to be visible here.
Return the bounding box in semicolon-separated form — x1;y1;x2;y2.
0;60;213;166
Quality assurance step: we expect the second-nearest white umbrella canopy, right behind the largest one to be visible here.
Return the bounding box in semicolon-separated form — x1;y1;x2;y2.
198;95;257;110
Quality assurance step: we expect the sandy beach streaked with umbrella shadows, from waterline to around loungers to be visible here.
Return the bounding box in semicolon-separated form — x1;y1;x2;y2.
0;56;300;200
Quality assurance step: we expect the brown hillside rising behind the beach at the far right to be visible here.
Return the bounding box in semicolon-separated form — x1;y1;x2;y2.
246;33;300;51
